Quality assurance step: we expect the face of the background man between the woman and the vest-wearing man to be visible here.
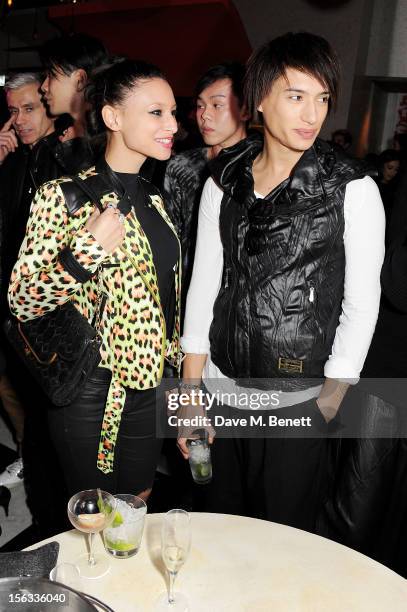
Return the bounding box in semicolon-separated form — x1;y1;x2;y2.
196;79;246;148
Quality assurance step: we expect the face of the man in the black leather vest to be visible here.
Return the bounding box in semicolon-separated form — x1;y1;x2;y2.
258;68;329;152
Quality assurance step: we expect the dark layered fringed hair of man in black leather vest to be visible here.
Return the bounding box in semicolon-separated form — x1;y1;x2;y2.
244;32;340;115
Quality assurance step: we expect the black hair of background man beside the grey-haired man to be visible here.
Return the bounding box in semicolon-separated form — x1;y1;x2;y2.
40;33;108;76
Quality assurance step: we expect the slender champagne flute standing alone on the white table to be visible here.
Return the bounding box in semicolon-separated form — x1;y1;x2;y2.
157;509;191;612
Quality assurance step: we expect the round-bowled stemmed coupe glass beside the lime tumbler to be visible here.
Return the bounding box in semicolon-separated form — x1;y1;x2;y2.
68;489;117;578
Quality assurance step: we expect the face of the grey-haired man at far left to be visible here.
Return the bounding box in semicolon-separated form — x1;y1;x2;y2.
7;83;54;146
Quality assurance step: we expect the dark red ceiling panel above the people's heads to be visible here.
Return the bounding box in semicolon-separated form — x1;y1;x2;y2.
49;0;251;96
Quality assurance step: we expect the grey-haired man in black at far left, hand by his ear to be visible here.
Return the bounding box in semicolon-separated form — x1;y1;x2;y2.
0;72;54;460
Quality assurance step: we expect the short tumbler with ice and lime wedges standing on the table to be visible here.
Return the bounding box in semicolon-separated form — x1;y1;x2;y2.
103;493;147;559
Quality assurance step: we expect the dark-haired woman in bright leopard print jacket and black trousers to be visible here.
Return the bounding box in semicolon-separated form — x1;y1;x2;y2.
9;59;180;498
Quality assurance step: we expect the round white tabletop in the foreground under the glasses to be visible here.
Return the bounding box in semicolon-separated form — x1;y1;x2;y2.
31;513;407;612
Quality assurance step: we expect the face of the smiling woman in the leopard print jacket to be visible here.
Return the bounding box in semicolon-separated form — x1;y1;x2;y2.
116;78;177;160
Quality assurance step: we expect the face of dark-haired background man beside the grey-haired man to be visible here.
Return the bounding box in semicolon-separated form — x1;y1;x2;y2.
41;71;78;116
